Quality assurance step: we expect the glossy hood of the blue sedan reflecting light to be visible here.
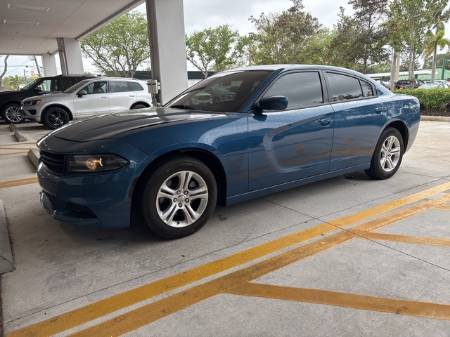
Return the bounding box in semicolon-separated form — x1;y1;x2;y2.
51;108;226;142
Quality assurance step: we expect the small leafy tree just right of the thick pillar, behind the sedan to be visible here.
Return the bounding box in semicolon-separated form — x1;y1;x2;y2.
186;25;251;78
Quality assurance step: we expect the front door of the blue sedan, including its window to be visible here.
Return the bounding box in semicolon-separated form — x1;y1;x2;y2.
249;71;334;191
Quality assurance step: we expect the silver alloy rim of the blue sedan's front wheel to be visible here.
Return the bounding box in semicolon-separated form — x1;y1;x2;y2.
156;171;208;228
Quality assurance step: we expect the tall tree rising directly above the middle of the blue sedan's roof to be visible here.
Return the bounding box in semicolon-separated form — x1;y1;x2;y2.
250;0;323;64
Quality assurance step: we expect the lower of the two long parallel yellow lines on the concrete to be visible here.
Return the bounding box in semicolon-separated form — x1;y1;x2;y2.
67;196;442;337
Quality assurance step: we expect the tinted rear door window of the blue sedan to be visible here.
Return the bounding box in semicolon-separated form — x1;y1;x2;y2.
327;73;363;102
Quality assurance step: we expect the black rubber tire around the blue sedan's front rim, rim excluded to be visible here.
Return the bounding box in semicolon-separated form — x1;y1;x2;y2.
141;157;217;239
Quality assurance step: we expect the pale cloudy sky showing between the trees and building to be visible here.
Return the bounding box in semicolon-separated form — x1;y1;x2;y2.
1;0;450;75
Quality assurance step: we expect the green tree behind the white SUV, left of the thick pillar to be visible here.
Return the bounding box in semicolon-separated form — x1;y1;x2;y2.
81;12;150;77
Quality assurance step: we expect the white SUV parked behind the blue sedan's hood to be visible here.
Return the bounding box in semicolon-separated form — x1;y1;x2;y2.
22;77;152;129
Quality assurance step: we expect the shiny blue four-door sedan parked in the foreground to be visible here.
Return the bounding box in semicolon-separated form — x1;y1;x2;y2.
38;65;420;239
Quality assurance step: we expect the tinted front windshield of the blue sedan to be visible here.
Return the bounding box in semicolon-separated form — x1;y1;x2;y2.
166;70;272;112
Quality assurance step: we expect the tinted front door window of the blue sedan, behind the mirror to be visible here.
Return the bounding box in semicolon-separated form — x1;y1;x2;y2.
264;71;323;109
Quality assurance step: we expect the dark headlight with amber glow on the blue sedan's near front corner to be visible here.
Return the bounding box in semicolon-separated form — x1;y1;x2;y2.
66;154;128;172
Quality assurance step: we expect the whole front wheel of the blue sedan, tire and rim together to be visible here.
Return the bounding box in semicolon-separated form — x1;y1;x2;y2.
141;157;217;239
